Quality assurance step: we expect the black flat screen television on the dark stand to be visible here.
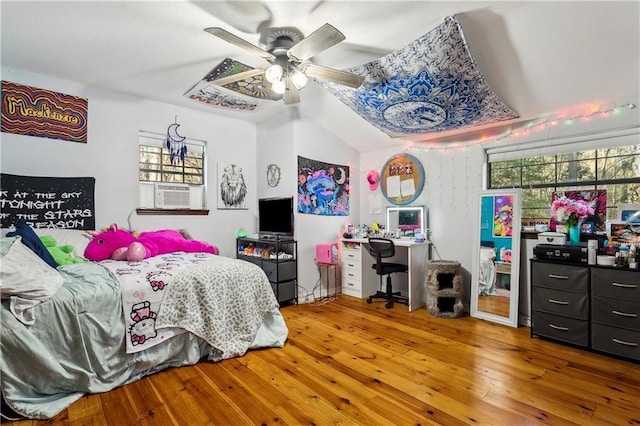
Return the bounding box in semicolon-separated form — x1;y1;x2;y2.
258;197;293;238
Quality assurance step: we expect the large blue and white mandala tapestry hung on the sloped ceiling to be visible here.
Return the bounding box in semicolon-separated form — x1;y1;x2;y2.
314;16;518;137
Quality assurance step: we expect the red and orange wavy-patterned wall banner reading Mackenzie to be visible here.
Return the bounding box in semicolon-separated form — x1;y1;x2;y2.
1;81;88;143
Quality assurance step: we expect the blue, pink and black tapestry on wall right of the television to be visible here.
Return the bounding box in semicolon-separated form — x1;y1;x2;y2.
298;156;349;216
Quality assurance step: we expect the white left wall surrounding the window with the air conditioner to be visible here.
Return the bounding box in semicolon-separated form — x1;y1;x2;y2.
0;68;256;256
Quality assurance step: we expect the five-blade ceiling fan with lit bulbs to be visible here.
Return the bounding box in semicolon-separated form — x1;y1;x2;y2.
205;24;364;104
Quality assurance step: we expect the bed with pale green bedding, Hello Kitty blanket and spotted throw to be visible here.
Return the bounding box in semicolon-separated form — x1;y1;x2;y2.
0;174;288;419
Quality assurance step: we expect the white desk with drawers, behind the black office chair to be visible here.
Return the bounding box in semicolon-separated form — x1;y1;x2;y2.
340;238;430;312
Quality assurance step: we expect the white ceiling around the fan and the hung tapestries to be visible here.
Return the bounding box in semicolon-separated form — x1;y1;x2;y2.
1;0;640;151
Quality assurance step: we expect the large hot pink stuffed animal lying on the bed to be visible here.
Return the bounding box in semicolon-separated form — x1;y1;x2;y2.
84;224;218;261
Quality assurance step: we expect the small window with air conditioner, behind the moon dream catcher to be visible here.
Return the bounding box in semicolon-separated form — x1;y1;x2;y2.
138;131;206;209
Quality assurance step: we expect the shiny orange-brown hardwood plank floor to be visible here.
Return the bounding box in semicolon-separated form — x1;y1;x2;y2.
8;296;640;426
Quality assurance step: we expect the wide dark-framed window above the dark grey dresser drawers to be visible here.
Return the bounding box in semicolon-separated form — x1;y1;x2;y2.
487;144;640;222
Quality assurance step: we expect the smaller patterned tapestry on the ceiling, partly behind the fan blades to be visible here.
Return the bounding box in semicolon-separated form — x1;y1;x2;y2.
184;58;282;111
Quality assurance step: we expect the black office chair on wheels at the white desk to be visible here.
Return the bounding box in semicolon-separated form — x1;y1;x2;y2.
367;237;409;309
